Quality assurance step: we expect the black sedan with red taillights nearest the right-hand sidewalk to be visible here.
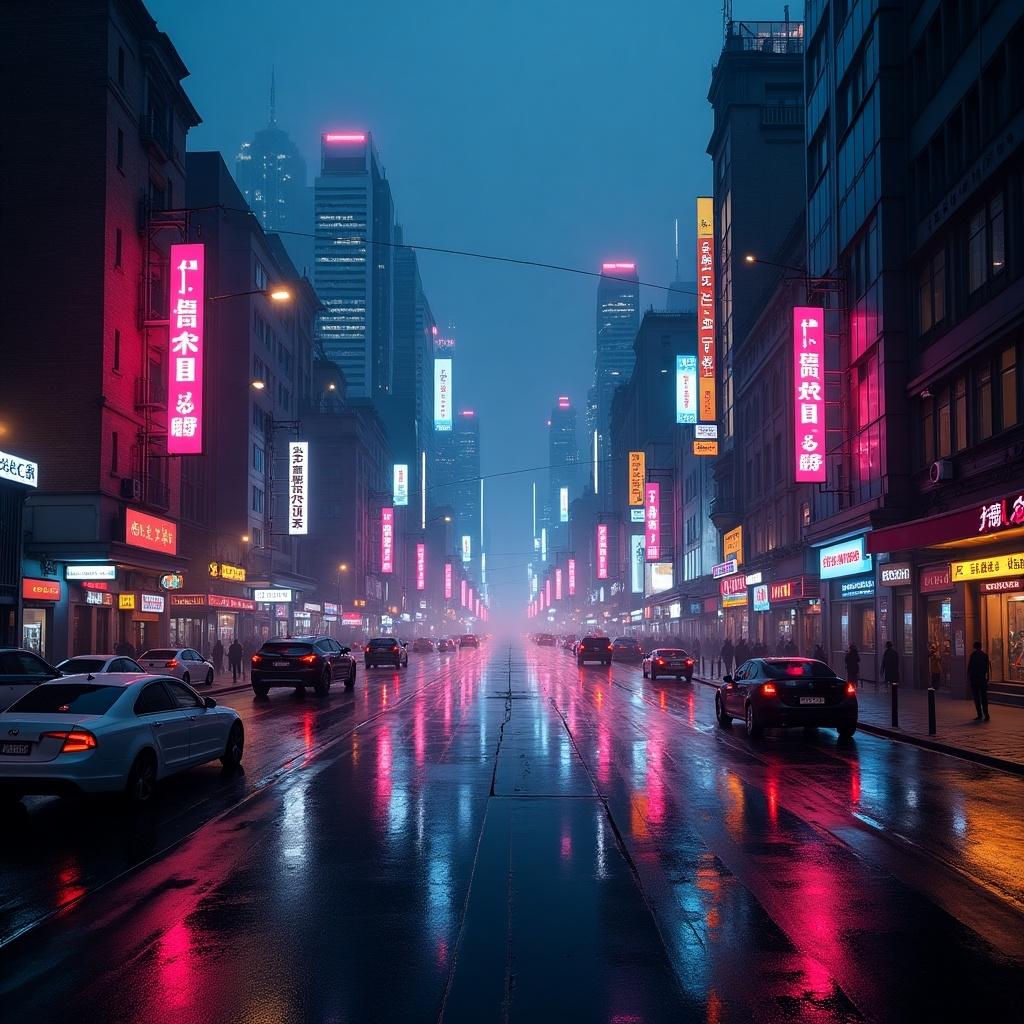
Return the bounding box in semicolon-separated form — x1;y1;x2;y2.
715;657;857;739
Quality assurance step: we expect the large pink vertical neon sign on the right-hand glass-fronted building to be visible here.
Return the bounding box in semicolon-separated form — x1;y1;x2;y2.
793;306;825;483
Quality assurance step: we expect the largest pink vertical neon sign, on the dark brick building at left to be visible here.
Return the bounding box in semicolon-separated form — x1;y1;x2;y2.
167;243;206;455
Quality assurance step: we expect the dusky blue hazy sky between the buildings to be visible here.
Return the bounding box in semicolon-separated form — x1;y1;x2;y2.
147;0;782;606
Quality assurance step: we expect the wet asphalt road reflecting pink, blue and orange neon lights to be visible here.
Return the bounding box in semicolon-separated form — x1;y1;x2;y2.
0;643;1024;1024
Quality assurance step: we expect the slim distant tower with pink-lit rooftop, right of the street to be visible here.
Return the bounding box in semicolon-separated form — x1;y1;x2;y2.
594;262;640;469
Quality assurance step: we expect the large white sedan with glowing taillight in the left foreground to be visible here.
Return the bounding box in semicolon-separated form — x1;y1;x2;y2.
0;672;245;804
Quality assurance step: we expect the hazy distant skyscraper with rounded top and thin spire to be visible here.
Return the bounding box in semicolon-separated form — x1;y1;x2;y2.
234;73;312;271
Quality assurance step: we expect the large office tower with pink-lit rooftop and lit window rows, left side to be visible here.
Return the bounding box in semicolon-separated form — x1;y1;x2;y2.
313;131;394;398
